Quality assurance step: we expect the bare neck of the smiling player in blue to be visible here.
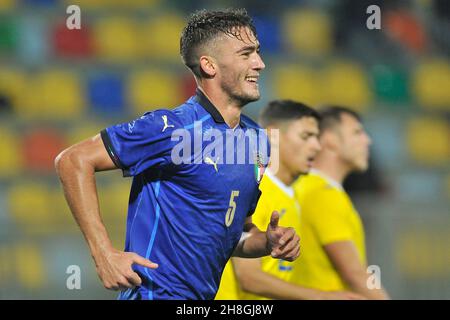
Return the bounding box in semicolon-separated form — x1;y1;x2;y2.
199;86;242;128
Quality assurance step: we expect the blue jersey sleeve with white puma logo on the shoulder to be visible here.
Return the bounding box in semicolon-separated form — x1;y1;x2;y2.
101;110;182;176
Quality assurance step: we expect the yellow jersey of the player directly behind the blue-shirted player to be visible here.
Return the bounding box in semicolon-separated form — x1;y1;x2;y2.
216;170;300;300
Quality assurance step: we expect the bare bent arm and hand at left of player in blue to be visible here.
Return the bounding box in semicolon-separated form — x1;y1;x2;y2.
55;134;157;290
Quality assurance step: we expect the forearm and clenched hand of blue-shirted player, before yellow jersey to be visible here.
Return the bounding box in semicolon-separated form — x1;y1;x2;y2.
233;211;300;261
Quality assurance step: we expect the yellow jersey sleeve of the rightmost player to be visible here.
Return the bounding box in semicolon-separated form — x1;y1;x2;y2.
303;190;353;245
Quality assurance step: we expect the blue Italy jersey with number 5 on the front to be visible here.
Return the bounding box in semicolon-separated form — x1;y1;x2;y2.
101;90;268;299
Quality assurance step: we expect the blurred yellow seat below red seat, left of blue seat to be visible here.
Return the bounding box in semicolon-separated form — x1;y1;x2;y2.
20;70;86;121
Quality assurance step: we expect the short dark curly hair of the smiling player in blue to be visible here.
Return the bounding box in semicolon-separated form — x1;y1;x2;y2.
180;9;256;77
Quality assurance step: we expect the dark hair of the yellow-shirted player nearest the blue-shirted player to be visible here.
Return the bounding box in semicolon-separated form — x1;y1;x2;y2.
259;100;320;128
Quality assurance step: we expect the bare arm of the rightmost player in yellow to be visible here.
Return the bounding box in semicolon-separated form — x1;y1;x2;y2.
324;241;389;300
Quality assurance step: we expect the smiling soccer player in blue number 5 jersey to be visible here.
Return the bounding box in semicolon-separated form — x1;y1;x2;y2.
55;10;300;299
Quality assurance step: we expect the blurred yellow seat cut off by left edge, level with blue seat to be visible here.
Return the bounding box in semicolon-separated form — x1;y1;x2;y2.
0;66;27;111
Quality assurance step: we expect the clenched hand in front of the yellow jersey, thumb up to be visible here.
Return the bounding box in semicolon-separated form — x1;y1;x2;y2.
266;211;300;261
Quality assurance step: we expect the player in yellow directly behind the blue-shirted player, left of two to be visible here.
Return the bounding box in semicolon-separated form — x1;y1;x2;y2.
216;100;364;300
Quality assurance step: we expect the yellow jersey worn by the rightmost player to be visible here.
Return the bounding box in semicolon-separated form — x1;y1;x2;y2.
294;170;366;291
